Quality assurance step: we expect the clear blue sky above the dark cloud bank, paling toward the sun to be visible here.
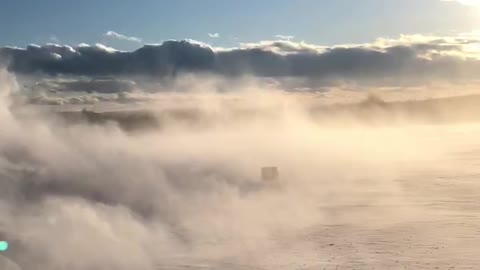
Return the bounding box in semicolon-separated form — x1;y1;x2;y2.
0;0;480;50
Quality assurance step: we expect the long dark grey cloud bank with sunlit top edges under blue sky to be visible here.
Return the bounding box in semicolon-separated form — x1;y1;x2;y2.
0;32;480;84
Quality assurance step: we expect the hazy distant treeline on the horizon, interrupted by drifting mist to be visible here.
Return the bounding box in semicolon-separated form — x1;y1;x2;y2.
55;95;480;131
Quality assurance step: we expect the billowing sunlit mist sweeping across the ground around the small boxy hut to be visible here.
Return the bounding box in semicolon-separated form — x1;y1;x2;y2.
0;72;480;270
